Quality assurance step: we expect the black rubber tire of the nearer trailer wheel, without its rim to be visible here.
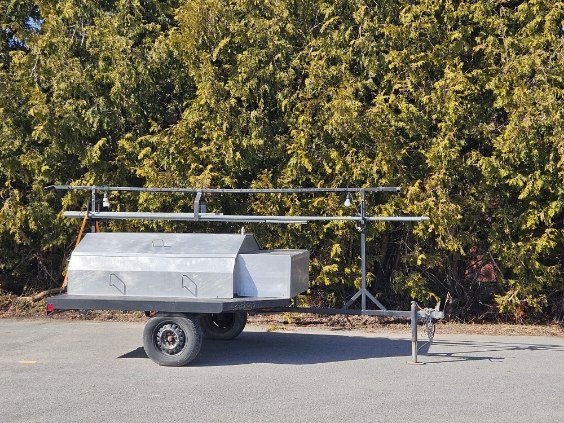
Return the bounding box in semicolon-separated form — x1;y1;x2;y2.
143;314;203;367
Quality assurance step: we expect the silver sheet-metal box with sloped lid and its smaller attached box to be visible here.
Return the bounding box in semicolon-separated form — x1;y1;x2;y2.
67;233;309;298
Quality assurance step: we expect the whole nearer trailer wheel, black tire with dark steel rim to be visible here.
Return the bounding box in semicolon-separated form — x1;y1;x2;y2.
143;314;202;367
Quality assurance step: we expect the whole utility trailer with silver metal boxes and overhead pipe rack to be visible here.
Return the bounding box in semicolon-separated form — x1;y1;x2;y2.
47;185;444;366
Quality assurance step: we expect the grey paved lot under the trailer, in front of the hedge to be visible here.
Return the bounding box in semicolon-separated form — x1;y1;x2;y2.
0;319;564;423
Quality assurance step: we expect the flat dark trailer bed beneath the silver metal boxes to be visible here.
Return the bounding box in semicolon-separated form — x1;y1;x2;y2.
47;294;290;314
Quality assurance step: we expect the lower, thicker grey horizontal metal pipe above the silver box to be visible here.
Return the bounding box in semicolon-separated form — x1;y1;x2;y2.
63;211;429;224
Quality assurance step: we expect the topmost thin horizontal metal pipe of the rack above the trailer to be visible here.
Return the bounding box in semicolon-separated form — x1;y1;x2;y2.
45;185;401;194
